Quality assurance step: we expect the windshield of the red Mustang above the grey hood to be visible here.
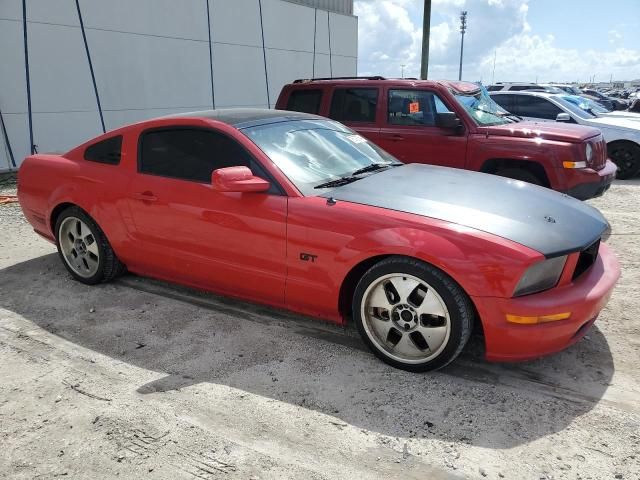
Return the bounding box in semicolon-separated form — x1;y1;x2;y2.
242;120;401;195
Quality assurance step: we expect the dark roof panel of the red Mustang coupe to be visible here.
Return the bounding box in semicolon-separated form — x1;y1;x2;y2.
162;108;326;128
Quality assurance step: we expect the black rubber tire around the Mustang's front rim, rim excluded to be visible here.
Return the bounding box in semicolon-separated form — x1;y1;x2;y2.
352;256;475;372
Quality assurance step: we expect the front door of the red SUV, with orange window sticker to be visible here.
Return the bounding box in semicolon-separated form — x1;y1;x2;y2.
377;88;467;168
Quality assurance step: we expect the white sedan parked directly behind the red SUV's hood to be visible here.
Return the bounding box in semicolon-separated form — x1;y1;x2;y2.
491;92;640;179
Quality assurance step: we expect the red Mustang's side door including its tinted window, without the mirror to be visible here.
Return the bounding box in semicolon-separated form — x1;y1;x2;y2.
129;127;287;304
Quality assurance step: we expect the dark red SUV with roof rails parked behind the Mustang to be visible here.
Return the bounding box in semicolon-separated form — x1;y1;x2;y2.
276;77;616;200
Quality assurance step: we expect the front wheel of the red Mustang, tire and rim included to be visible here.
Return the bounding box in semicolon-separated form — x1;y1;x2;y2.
353;257;474;372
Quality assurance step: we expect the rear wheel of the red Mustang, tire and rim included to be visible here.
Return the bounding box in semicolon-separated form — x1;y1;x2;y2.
55;207;125;285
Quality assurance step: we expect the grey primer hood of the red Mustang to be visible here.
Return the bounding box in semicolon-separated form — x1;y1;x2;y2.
322;164;608;257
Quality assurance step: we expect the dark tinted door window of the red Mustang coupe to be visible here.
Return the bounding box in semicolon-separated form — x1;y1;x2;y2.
138;128;251;183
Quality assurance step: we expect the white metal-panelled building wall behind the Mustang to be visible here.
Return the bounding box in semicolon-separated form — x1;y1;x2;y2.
0;0;358;171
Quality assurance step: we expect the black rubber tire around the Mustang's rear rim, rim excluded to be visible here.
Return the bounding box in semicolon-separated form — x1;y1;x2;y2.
54;206;126;285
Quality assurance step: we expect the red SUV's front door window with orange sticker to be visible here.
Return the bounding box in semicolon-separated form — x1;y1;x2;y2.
387;90;450;127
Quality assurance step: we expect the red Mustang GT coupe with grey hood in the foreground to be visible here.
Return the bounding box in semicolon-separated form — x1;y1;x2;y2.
18;109;620;371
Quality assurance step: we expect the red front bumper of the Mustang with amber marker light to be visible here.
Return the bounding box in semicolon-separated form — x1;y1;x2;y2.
472;244;620;361
